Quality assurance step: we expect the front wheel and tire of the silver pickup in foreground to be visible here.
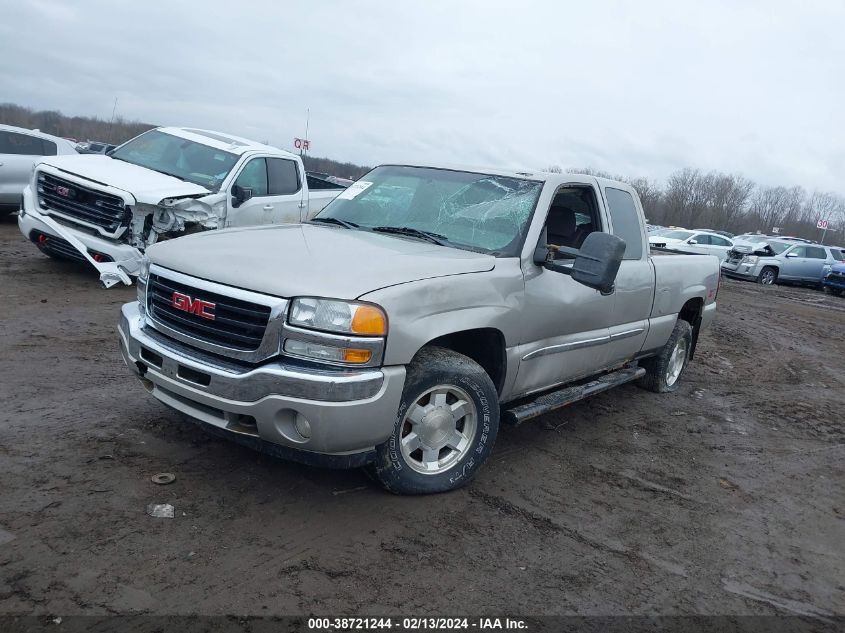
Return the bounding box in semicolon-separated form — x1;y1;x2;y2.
369;347;499;495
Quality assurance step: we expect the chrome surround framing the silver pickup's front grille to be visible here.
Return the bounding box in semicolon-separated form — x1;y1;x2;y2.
145;264;288;363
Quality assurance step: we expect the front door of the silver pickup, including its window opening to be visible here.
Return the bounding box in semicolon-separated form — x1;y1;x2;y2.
514;184;614;394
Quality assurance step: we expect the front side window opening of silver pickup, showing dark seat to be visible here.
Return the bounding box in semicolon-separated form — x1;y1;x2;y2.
546;187;602;258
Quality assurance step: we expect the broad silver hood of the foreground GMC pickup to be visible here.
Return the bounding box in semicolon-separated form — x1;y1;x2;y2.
147;224;496;301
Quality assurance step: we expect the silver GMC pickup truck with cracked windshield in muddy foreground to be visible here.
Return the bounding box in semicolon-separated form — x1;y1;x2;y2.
119;165;719;494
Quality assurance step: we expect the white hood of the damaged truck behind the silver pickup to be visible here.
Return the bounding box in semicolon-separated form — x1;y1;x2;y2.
41;154;211;204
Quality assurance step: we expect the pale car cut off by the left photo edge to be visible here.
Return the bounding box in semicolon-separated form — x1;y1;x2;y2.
0;125;76;215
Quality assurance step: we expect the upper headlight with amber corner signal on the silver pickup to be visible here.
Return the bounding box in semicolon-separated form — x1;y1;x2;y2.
288;297;387;336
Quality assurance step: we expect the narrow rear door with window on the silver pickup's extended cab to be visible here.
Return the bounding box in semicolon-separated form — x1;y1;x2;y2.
604;187;654;364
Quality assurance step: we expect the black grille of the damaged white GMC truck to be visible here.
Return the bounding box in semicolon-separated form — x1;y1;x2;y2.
37;171;127;234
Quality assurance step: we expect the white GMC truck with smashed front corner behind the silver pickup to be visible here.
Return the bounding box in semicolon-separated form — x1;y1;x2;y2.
18;127;344;288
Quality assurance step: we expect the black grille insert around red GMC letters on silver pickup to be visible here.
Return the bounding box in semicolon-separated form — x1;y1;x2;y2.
147;274;271;351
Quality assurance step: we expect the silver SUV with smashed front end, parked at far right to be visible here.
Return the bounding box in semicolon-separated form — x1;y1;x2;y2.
722;239;845;285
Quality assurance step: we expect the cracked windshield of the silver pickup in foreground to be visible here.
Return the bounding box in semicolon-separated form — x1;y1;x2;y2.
314;166;542;256
